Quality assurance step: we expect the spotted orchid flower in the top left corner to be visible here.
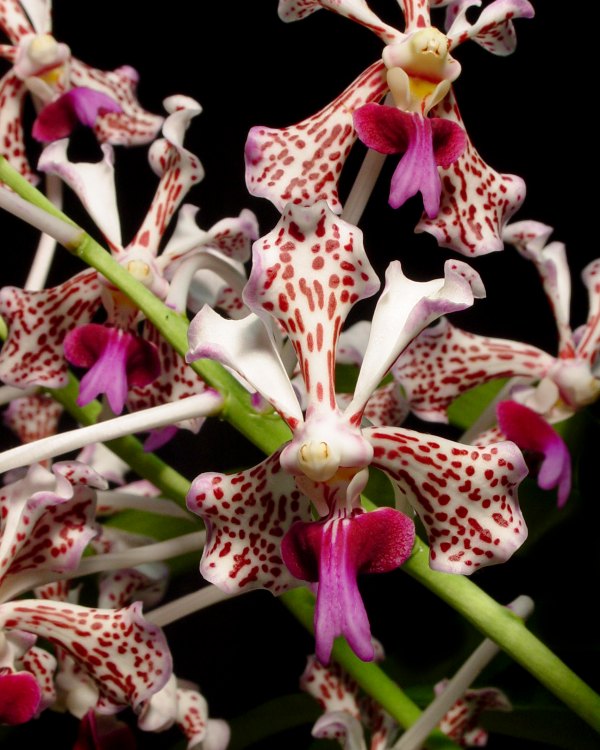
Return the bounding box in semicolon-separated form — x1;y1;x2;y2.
0;0;163;182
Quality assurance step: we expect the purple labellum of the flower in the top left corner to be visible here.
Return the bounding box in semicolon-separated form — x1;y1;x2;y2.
32;86;123;143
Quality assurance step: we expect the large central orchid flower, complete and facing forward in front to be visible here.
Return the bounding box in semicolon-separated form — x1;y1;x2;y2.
187;201;526;662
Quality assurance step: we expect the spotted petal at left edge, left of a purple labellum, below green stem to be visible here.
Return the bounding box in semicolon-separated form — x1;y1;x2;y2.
0;269;100;388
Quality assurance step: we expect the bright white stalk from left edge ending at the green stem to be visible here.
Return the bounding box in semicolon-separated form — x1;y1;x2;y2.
0;390;223;472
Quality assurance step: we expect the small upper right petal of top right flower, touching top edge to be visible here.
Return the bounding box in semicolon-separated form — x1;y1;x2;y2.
447;0;534;56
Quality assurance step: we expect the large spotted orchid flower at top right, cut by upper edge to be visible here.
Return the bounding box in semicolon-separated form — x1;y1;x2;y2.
246;0;533;255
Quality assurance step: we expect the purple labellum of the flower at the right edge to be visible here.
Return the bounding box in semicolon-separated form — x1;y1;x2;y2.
496;401;571;508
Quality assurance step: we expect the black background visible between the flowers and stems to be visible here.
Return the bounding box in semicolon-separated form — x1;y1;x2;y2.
0;0;599;749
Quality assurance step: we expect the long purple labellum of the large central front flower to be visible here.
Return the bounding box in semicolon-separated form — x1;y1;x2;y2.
281;508;415;664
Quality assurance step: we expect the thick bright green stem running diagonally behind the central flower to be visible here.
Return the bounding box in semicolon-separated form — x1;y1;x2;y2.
0;159;600;732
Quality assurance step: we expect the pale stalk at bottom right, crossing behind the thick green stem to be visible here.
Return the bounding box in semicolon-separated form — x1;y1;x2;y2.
391;596;533;750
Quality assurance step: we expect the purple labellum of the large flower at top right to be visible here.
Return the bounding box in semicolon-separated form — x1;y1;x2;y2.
354;103;467;219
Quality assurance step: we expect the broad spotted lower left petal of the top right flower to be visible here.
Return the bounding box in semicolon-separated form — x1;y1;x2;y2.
245;62;388;213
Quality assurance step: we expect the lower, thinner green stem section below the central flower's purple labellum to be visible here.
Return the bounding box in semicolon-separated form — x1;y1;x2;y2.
279;588;458;749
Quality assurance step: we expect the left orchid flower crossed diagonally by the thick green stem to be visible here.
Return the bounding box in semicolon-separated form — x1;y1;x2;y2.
0;96;257;431
